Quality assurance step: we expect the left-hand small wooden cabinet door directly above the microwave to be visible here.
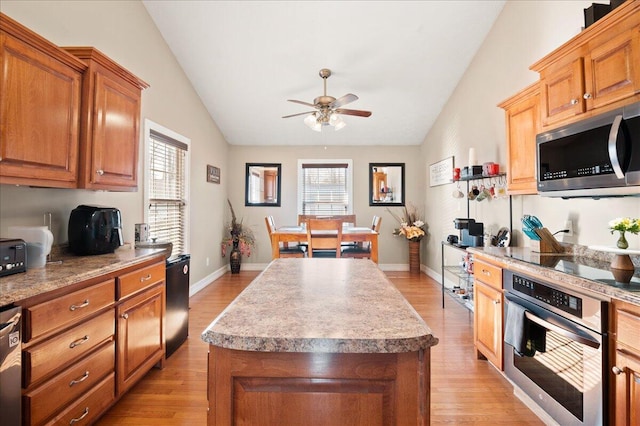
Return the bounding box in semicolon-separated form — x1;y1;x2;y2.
540;57;585;126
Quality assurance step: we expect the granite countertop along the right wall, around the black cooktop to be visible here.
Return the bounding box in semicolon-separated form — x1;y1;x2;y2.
467;245;640;306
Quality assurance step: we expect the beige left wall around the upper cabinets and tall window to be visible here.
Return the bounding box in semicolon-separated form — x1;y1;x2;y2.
0;0;228;284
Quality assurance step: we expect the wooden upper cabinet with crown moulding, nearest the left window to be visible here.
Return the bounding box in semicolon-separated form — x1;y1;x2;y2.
64;47;149;191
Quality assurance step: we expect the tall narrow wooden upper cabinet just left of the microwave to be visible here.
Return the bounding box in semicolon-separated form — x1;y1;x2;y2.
498;83;540;195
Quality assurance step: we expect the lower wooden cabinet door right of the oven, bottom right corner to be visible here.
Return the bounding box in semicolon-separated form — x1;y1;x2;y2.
613;349;640;426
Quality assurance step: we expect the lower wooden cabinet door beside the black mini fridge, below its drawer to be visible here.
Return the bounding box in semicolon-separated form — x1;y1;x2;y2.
117;282;165;395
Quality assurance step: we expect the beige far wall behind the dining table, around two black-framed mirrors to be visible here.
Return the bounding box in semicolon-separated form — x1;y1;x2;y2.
223;146;426;268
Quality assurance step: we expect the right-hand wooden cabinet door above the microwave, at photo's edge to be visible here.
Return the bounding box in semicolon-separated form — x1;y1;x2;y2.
584;28;640;110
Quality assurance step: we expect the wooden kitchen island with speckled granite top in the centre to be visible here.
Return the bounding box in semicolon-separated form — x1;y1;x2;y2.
202;259;438;425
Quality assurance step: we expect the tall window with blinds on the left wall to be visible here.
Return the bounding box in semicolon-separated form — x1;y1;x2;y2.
147;129;188;255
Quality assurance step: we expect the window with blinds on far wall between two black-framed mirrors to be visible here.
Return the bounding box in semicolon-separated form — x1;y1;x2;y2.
301;163;350;215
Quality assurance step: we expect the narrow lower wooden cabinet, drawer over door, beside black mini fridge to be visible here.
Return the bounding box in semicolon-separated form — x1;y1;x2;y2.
116;262;166;395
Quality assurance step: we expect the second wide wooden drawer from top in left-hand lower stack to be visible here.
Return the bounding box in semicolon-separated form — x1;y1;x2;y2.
23;309;115;387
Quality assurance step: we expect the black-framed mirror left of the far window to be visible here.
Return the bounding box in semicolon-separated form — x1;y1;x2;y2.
244;163;281;207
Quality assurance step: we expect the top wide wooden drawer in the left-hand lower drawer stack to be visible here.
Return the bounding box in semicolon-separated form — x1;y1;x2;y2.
25;279;115;342
